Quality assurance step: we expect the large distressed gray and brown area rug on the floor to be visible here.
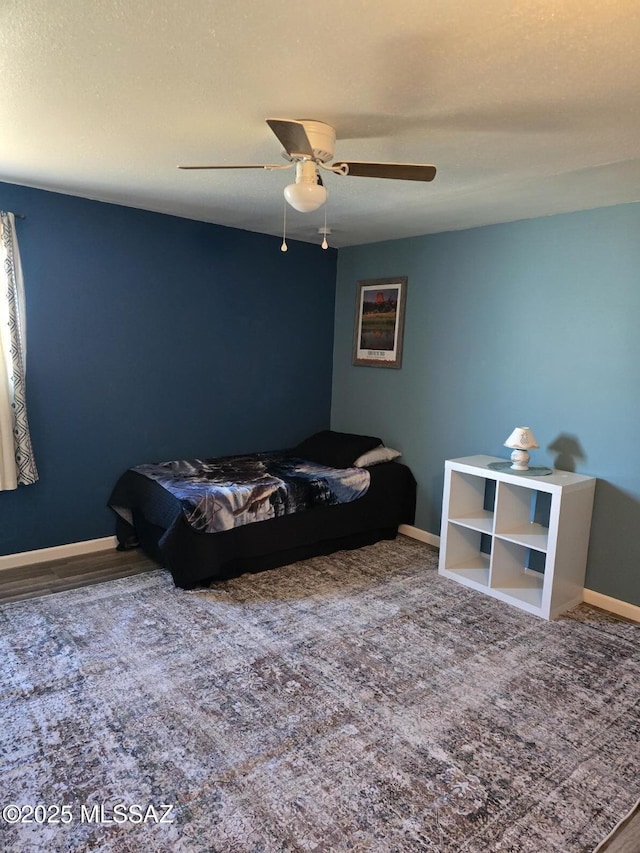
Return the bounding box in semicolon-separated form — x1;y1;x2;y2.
0;537;640;853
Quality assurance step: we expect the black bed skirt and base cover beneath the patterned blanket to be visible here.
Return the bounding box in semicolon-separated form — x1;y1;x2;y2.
111;462;416;589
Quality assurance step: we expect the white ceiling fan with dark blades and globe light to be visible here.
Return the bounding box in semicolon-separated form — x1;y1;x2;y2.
178;118;436;213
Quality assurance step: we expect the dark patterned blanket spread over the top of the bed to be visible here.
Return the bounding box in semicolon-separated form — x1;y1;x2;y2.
132;453;370;533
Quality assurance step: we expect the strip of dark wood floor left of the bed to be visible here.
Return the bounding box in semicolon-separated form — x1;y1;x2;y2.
0;548;158;602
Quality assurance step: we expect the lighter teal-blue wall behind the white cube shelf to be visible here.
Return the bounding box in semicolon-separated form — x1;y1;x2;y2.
332;204;640;605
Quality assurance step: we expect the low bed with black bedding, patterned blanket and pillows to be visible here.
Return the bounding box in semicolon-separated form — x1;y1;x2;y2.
108;430;416;589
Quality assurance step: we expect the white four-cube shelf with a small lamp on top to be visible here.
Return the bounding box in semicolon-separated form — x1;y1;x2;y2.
438;456;596;619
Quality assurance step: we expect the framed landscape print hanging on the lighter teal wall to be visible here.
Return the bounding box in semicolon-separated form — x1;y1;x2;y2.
353;276;407;369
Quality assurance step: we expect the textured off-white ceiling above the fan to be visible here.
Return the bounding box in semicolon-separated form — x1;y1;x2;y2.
0;0;640;246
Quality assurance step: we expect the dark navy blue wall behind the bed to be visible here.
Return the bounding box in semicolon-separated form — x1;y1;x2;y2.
0;184;337;554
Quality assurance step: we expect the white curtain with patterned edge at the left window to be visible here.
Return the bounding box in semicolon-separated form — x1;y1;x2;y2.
0;211;38;491
